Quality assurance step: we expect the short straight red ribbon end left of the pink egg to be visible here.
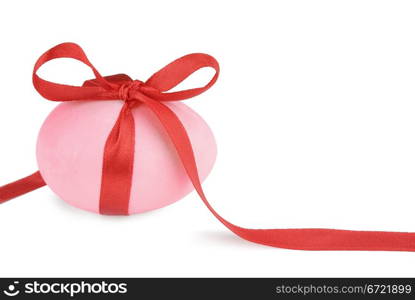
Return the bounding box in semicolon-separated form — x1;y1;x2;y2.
0;171;46;203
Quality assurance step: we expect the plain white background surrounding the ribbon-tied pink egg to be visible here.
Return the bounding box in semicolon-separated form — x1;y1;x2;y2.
0;0;415;276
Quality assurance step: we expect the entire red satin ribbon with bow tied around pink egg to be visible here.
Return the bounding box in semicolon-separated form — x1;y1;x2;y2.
0;43;415;251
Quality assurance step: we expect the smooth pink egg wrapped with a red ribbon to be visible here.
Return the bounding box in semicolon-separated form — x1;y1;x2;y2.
37;101;216;214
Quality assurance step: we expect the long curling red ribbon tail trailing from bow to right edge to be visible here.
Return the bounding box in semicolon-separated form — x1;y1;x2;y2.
145;99;415;251
